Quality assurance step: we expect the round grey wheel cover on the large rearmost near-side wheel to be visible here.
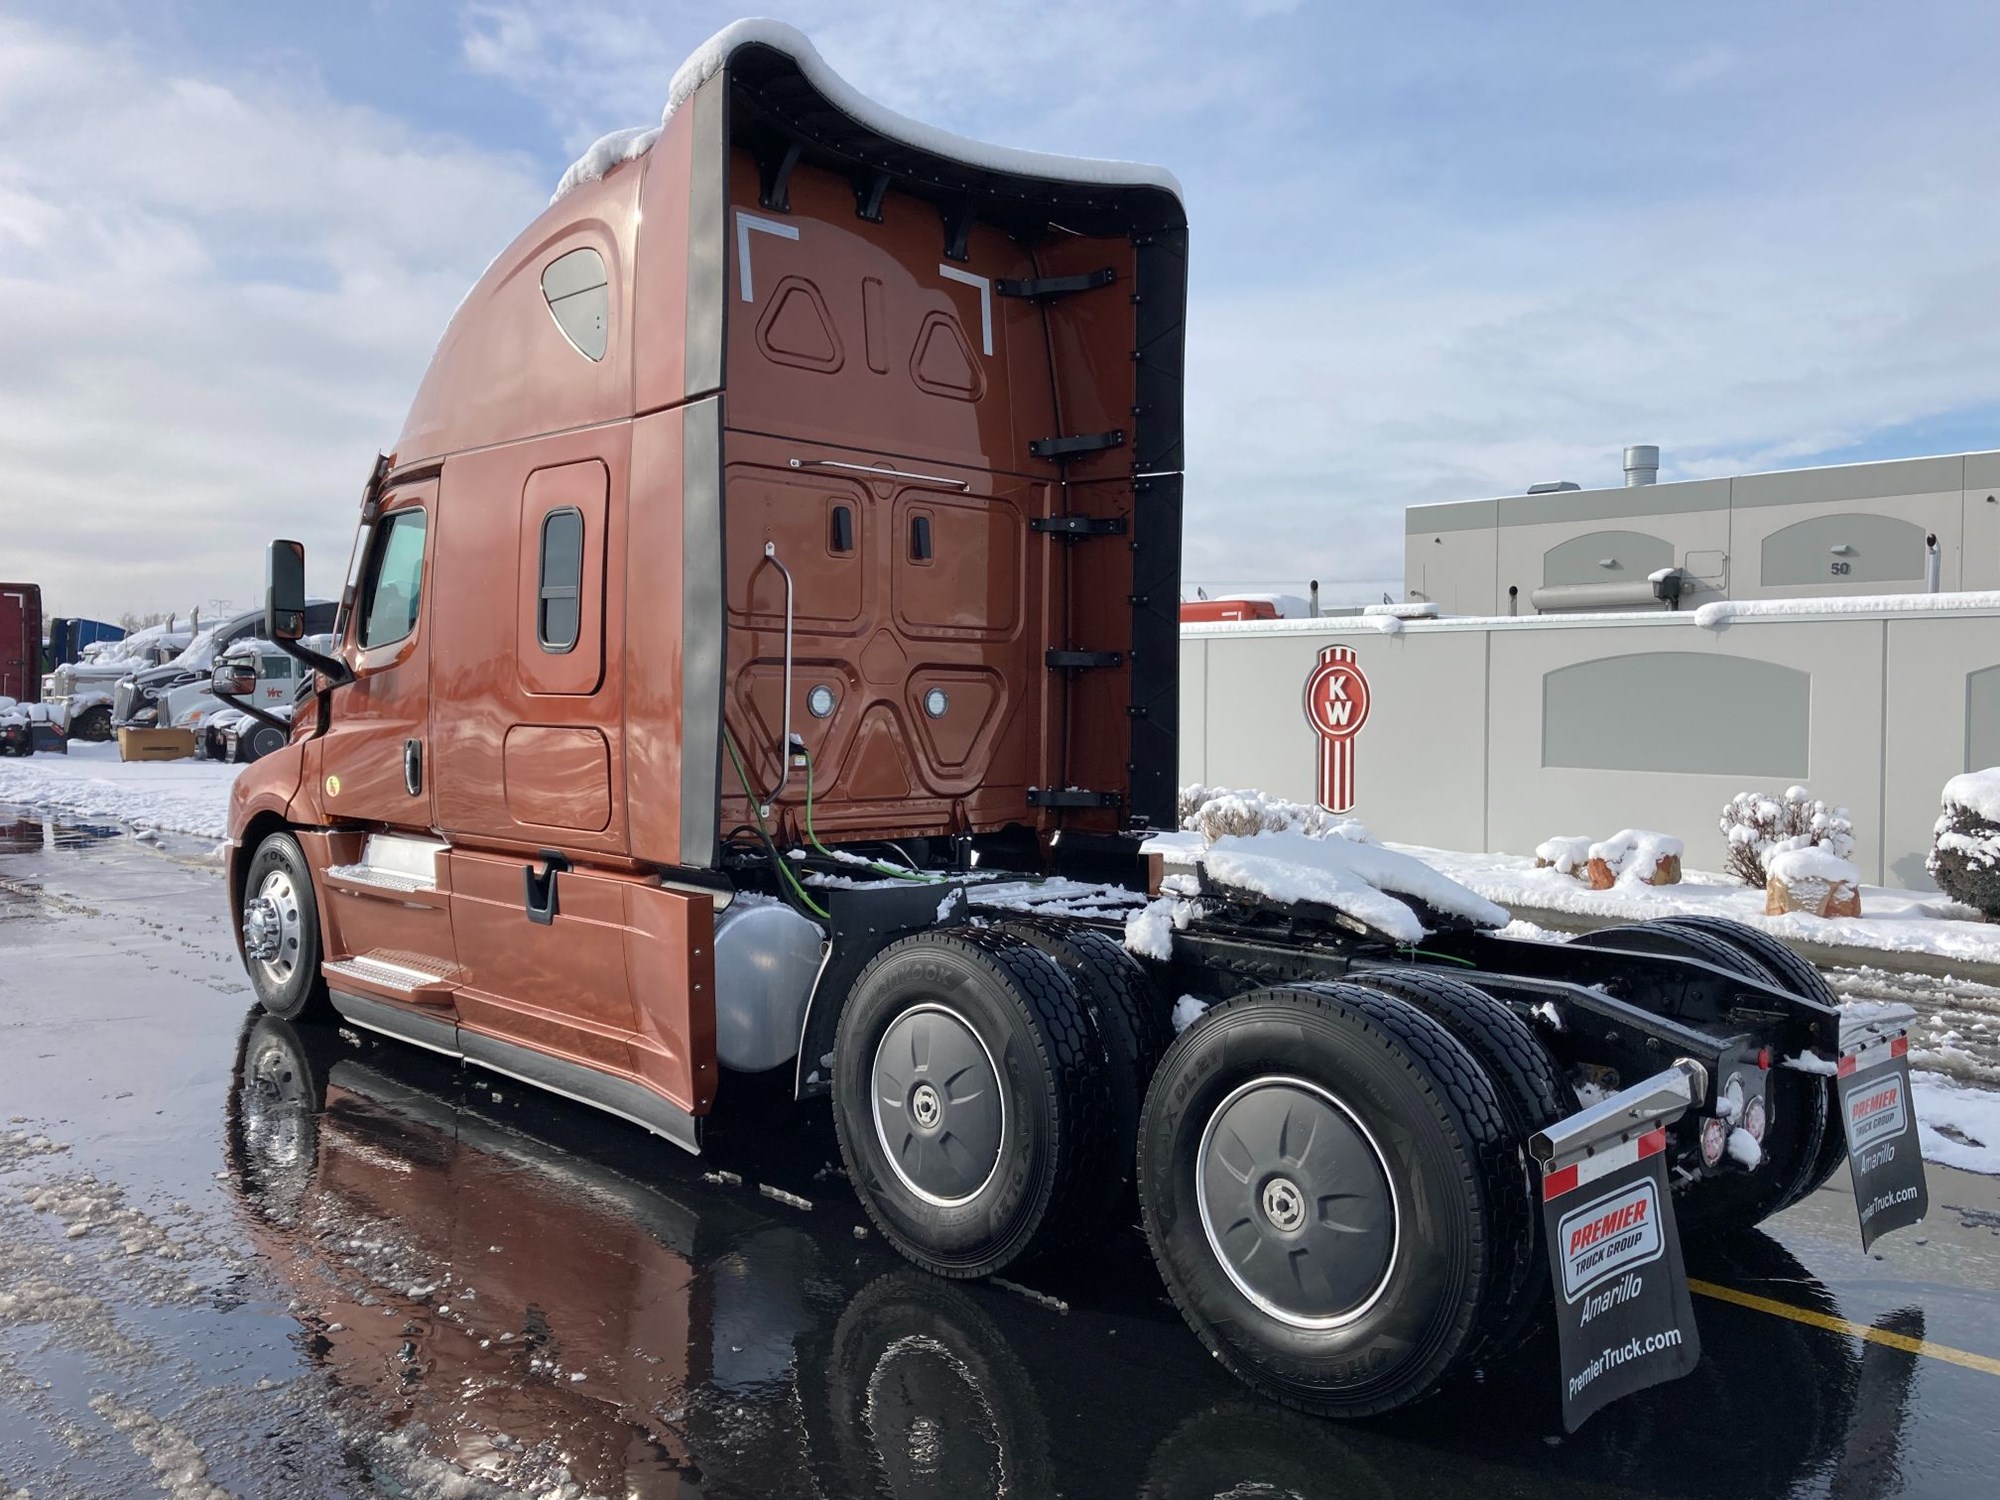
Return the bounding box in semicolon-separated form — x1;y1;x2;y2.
1194;1076;1402;1330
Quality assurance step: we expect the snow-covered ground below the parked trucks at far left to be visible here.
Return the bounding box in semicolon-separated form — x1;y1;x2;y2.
0;744;242;838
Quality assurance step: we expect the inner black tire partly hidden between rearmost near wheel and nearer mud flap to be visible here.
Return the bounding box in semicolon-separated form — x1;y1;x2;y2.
1350;966;1578;1356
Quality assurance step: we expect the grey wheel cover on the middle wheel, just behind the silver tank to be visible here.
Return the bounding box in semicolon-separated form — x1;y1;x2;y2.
872;1004;1006;1208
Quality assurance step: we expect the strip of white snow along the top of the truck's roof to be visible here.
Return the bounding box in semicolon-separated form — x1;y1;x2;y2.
550;18;1180;202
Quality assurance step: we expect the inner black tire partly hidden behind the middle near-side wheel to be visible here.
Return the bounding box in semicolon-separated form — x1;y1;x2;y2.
1002;918;1172;1224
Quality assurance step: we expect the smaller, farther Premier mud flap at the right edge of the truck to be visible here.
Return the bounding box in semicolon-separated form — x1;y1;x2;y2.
1834;1006;1930;1250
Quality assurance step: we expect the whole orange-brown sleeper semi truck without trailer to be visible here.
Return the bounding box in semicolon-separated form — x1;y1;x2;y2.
216;22;1920;1420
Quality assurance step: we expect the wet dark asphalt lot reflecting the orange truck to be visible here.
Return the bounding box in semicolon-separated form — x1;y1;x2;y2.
0;812;2000;1500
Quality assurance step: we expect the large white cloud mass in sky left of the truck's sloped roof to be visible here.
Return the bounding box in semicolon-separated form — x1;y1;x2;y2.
0;20;546;616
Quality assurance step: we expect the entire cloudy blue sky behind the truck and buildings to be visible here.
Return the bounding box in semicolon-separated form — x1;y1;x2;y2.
0;0;2000;616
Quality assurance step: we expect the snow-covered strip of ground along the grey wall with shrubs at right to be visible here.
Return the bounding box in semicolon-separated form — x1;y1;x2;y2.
1392;844;2000;964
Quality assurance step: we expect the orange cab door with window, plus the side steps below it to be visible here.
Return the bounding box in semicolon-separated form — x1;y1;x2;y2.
306;480;456;1034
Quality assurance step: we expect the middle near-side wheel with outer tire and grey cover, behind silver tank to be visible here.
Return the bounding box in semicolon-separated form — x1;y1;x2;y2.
834;928;1116;1278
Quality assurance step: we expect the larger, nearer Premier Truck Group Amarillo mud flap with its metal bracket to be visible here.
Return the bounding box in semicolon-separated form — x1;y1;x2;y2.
1530;1060;1708;1432
